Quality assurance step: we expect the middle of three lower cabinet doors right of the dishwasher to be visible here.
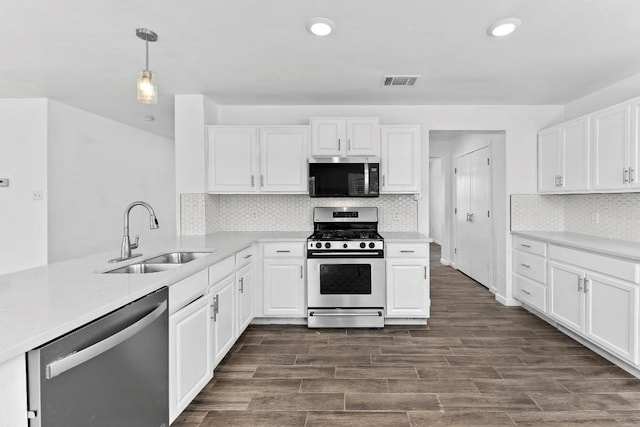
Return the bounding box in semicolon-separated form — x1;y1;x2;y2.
212;274;236;368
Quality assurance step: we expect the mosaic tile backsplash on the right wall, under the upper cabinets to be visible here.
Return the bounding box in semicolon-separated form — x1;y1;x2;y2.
511;193;640;242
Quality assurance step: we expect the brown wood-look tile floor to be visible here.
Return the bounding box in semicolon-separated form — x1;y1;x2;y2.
173;245;640;427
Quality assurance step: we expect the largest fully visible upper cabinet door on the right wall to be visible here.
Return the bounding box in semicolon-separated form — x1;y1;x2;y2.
591;104;631;190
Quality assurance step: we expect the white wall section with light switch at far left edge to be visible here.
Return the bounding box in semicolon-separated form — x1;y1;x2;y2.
0;99;47;274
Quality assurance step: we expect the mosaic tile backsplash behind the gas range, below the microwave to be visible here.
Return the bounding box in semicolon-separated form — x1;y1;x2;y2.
180;193;418;235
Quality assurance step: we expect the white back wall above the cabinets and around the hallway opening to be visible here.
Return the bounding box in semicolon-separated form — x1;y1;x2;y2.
218;105;563;304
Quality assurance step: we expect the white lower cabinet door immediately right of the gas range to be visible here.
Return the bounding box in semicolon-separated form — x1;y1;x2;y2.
386;259;429;317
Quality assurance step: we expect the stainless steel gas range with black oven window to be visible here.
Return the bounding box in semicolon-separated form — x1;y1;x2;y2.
307;207;386;328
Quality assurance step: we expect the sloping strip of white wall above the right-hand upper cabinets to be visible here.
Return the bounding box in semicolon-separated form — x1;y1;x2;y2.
564;73;640;120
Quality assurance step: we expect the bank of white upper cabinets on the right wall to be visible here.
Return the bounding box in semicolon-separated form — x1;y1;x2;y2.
538;98;640;193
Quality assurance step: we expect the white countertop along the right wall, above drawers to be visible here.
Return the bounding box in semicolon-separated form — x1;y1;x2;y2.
511;231;640;262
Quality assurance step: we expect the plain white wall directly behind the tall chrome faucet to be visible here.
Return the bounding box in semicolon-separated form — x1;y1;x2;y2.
48;101;176;262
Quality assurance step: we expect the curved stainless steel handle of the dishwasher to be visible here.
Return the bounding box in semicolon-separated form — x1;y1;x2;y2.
45;300;167;380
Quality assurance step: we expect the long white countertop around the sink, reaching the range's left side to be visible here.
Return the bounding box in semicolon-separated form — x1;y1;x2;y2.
0;231;311;363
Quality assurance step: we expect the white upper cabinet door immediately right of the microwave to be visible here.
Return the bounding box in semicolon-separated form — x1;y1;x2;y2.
380;126;420;193
